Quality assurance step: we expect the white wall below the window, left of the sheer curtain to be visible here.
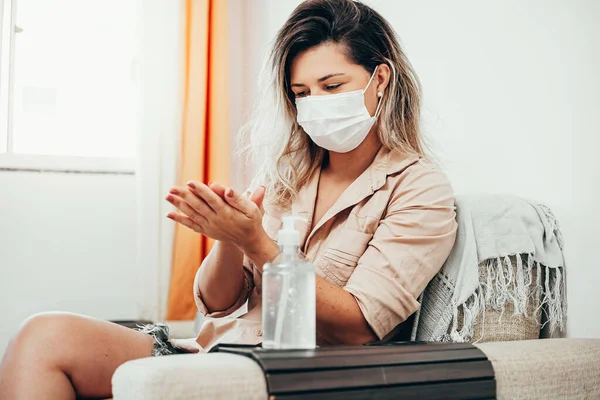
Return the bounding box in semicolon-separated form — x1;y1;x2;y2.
0;171;141;357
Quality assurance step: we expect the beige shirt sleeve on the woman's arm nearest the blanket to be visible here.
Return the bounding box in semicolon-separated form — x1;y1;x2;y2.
345;161;457;339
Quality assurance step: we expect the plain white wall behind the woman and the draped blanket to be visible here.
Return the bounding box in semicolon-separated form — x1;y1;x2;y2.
240;0;600;337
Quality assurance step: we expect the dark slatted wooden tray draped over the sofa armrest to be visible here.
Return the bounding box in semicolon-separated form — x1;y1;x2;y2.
211;342;496;400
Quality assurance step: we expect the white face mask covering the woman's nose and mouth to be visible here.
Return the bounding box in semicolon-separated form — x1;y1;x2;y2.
296;68;383;153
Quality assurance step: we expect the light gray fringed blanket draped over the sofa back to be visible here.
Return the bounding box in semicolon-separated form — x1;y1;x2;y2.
412;195;567;342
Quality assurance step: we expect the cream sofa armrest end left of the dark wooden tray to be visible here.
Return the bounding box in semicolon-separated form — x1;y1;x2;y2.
112;353;267;400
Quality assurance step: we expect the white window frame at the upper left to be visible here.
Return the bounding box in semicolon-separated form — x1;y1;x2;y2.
0;0;137;175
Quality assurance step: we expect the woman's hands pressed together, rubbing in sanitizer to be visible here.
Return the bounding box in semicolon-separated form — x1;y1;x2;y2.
166;181;264;251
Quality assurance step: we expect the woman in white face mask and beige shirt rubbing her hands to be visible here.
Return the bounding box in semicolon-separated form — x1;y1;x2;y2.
0;0;456;399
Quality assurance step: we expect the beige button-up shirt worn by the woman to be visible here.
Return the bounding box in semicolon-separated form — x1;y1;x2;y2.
194;147;457;350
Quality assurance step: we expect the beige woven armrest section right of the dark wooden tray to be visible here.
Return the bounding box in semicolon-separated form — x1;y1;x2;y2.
475;339;600;400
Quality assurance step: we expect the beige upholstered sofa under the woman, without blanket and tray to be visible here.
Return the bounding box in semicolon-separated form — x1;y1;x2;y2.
112;265;600;400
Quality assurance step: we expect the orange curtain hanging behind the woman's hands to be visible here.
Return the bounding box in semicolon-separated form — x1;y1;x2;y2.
166;0;230;320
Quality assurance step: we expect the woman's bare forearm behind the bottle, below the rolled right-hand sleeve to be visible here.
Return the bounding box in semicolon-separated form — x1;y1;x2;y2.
243;233;377;344
